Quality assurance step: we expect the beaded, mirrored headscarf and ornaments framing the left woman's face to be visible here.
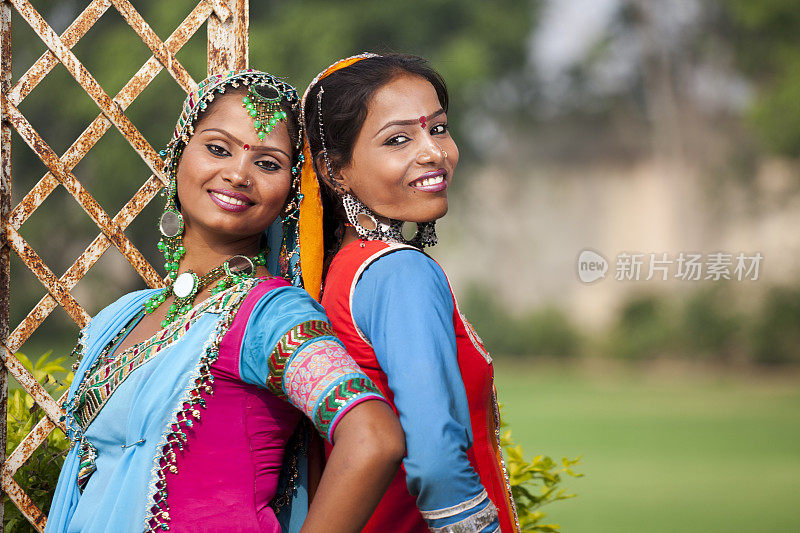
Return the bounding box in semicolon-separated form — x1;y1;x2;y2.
158;69;303;296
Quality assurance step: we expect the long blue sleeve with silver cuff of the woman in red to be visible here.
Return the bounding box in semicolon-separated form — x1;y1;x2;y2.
352;249;499;531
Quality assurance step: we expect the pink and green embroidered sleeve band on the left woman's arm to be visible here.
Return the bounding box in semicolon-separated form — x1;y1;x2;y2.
278;332;385;441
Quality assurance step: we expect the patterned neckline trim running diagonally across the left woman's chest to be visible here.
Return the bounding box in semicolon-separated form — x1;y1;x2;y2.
74;291;238;431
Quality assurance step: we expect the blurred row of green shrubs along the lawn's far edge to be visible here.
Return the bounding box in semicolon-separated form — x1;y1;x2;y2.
462;283;800;365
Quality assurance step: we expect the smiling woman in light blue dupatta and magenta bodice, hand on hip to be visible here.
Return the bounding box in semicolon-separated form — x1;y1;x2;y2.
46;69;403;532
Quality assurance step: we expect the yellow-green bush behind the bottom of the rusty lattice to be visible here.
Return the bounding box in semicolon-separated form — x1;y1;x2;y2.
3;352;72;533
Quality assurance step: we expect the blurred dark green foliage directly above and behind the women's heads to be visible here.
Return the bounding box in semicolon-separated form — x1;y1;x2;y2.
250;0;540;155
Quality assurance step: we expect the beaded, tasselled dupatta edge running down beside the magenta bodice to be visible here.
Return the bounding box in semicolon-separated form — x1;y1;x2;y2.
144;279;262;532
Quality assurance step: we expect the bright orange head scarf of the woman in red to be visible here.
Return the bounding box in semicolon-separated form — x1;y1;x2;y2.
298;53;380;300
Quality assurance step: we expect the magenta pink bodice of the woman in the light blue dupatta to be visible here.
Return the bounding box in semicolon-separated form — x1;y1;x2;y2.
161;280;376;533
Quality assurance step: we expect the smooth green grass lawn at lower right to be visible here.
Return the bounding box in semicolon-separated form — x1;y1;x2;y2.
496;359;800;533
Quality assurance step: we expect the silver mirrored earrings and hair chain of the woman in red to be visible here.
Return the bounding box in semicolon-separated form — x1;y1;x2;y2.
317;87;439;248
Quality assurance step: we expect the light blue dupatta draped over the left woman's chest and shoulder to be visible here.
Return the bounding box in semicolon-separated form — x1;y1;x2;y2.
45;280;257;533
